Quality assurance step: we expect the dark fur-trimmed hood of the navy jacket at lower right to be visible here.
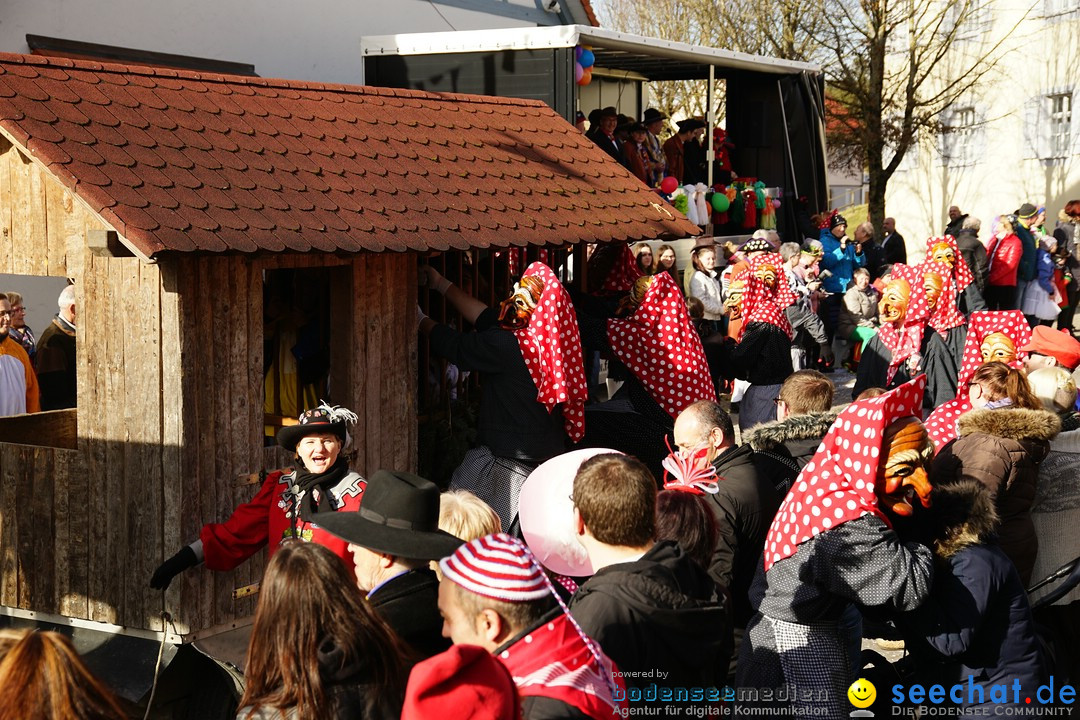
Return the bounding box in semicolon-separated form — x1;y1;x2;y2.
929;478;998;557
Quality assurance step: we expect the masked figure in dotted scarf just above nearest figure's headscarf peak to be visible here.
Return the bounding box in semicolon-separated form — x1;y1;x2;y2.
851;264;957;413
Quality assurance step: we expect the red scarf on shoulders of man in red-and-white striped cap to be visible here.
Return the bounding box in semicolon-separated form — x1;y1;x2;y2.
498;613;626;720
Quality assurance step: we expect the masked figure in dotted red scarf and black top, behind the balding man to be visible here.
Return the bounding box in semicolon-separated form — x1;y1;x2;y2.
720;253;798;432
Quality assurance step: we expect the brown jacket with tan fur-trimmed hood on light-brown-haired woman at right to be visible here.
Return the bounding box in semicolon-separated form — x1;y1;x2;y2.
931;408;1062;586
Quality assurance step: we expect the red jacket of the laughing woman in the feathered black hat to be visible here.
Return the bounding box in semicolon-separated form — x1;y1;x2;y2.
199;471;367;572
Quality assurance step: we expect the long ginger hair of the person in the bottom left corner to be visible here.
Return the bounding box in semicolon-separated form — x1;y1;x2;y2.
0;631;127;720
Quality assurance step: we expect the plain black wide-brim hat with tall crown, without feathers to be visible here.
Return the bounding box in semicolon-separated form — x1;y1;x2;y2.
312;470;463;560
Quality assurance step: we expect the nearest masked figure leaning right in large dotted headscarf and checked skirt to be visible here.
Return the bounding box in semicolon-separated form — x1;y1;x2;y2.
737;376;933;718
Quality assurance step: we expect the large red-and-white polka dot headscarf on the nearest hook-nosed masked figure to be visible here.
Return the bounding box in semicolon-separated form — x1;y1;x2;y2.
765;375;927;571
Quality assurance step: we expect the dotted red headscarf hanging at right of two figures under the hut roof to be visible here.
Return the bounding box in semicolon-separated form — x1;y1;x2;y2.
607;273;716;418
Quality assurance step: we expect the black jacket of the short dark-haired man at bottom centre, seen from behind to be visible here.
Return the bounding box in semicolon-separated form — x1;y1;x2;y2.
570;541;731;689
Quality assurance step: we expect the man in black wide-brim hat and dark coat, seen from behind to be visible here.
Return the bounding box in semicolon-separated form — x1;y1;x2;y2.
315;470;461;658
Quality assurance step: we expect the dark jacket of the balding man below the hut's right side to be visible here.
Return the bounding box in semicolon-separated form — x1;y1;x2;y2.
705;445;781;627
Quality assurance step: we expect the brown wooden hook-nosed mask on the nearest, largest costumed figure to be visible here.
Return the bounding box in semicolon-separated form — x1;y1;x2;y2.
874;418;934;517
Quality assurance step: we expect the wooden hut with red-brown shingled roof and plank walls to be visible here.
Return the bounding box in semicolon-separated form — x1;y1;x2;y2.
0;55;697;640
